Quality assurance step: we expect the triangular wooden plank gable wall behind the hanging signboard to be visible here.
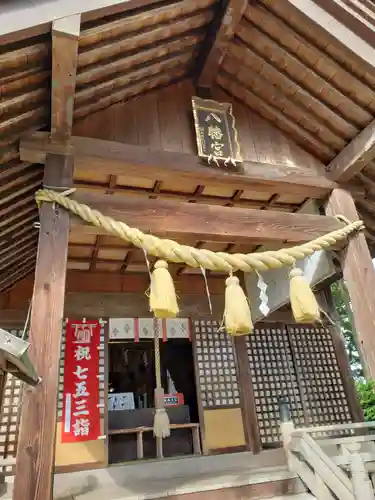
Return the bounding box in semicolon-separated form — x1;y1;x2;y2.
73;80;330;180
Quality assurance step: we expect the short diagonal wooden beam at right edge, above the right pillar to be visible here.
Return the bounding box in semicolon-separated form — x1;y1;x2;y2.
327;120;375;182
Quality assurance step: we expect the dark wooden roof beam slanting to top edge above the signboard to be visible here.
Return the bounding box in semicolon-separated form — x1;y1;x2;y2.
198;0;248;88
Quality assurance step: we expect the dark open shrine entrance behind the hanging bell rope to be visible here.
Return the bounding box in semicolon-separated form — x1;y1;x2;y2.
108;318;201;464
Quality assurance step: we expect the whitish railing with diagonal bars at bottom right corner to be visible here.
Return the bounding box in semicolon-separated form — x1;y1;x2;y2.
281;422;375;500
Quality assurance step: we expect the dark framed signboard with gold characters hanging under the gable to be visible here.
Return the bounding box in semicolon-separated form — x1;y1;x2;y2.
192;97;242;166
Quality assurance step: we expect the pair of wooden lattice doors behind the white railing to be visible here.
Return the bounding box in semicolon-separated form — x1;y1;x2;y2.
247;324;352;448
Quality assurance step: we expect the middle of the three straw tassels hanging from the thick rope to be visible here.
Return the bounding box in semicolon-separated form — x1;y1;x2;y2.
224;276;254;335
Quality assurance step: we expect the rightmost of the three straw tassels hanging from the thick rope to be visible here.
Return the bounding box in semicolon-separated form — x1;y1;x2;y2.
289;267;320;323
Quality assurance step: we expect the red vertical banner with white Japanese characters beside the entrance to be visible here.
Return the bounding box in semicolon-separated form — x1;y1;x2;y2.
61;320;100;443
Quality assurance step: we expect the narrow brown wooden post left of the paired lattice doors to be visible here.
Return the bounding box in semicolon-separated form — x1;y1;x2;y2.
234;336;261;453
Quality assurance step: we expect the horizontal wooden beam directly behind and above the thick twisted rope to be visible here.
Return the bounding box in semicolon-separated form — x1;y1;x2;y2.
72;191;343;243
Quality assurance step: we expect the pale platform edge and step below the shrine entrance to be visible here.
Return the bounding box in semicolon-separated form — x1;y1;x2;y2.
1;450;311;500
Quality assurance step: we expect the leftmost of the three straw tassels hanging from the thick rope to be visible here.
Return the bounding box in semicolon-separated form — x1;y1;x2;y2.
150;260;179;318
